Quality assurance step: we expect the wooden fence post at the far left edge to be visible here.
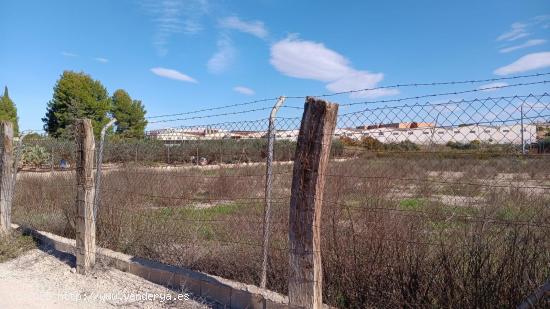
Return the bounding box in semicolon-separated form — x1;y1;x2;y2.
0;121;14;236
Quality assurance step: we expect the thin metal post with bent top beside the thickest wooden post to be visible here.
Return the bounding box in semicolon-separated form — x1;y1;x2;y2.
260;96;286;288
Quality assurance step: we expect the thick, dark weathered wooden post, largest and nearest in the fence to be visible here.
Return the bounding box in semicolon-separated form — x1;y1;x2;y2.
288;97;338;308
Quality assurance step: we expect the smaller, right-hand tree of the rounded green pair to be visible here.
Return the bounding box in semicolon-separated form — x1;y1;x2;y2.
112;89;147;138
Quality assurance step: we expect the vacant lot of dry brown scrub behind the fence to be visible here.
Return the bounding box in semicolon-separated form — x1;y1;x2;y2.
13;153;550;307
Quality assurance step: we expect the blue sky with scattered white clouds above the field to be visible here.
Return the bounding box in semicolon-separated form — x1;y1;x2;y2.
0;0;550;130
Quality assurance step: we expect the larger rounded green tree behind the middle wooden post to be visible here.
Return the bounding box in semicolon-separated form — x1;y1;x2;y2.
42;71;111;137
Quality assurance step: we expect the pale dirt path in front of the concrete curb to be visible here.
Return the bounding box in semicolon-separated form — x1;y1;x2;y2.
0;249;207;309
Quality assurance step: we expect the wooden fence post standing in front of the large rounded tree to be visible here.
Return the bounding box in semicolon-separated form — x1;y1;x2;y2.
75;119;96;274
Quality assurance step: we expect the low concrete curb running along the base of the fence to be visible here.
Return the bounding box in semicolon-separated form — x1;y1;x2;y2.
12;224;288;309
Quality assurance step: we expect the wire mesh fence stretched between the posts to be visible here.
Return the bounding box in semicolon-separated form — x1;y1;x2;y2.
9;71;550;307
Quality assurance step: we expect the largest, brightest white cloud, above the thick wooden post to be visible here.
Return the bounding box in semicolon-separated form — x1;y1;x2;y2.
270;36;399;98
